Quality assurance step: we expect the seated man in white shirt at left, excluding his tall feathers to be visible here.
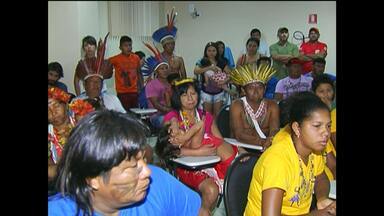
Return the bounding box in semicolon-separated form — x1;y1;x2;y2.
74;74;126;113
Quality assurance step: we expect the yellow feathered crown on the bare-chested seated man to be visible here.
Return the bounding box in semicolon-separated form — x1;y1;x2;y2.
230;64;276;86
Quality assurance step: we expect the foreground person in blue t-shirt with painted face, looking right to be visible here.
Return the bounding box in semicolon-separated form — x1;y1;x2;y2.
48;110;201;216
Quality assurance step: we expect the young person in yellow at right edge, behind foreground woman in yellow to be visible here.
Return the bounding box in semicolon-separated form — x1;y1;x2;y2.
312;74;336;180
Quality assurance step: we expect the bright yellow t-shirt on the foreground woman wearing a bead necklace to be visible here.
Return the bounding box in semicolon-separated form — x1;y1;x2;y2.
244;126;325;216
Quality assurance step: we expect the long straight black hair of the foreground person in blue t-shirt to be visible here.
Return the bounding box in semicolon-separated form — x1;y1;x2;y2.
57;110;148;215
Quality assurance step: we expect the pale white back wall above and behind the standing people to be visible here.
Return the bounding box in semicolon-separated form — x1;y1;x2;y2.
48;1;336;92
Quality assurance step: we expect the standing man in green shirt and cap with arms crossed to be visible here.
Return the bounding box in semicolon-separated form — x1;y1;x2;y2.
269;27;299;80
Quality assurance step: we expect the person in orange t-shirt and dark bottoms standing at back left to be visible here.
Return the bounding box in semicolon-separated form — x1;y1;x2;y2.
109;35;143;111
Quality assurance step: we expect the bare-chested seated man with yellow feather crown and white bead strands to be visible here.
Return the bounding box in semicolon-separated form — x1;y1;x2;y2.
229;65;280;149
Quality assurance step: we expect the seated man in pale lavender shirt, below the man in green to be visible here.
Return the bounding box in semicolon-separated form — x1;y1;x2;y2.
275;58;312;103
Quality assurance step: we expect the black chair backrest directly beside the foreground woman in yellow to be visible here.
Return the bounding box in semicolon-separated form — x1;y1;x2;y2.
224;153;260;216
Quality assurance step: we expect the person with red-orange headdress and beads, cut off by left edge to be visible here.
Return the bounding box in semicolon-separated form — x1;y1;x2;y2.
48;87;76;182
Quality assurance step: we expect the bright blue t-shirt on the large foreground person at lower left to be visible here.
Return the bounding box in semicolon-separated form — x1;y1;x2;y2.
48;165;201;216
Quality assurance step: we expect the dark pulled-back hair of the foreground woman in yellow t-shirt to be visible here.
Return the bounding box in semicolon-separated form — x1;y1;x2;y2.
285;91;329;126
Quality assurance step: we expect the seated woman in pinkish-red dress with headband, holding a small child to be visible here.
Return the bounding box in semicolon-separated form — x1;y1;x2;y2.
157;79;244;215
